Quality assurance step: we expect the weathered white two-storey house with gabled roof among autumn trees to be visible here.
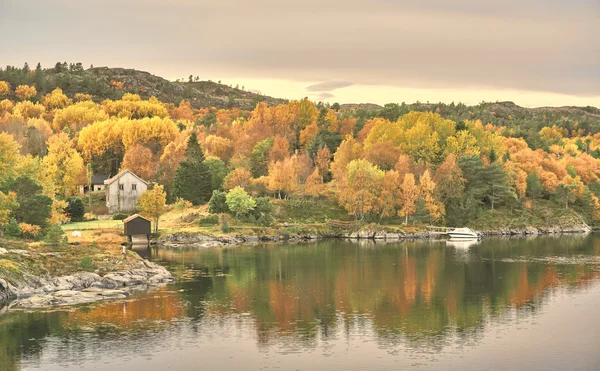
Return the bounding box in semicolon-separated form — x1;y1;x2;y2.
104;170;148;213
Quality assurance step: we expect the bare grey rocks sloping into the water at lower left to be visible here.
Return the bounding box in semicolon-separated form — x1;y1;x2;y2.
0;261;175;308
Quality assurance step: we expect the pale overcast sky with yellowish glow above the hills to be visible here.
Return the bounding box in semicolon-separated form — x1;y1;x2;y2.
0;0;600;107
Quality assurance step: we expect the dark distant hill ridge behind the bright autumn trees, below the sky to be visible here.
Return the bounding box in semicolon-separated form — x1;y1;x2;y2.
0;63;600;134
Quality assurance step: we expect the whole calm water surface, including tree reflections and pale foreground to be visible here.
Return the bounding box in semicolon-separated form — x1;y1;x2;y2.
0;235;600;371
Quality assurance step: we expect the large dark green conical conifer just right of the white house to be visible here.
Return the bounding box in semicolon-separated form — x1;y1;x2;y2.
173;133;213;205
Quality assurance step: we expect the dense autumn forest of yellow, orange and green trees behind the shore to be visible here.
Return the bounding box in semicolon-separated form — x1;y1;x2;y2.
0;63;600;237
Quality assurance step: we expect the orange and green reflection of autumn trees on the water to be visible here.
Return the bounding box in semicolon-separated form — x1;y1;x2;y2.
0;236;600;370
